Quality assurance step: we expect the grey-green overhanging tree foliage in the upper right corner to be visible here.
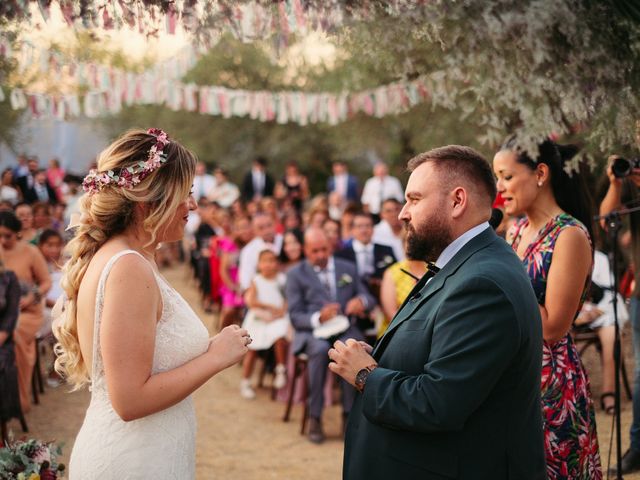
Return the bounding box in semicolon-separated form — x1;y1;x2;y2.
343;0;640;162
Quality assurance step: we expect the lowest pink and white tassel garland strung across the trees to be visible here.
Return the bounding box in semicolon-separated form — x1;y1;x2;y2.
0;72;430;126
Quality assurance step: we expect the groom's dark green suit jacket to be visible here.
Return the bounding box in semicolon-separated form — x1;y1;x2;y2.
343;228;546;480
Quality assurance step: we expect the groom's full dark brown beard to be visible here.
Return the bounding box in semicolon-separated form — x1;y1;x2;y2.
404;215;453;262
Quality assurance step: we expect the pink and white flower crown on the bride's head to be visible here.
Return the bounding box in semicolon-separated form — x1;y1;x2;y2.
82;128;171;195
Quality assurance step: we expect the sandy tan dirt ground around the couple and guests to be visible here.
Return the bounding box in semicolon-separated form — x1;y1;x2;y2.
9;266;640;480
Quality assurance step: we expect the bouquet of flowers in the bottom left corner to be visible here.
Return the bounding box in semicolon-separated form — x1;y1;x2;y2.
0;439;65;480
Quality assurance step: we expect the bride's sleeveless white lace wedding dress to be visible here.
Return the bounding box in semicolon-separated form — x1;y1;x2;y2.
69;250;209;480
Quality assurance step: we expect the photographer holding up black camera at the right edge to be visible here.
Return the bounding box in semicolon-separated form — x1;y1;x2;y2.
600;155;640;474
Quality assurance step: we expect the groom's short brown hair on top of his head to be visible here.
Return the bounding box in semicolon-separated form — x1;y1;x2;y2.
407;145;497;203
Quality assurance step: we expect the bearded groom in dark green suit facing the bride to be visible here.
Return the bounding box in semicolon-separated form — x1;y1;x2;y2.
329;146;546;480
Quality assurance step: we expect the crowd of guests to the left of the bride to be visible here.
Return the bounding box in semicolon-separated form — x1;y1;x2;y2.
0;156;74;438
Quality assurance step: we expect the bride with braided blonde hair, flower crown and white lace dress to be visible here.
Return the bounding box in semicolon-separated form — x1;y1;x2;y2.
55;129;251;480
